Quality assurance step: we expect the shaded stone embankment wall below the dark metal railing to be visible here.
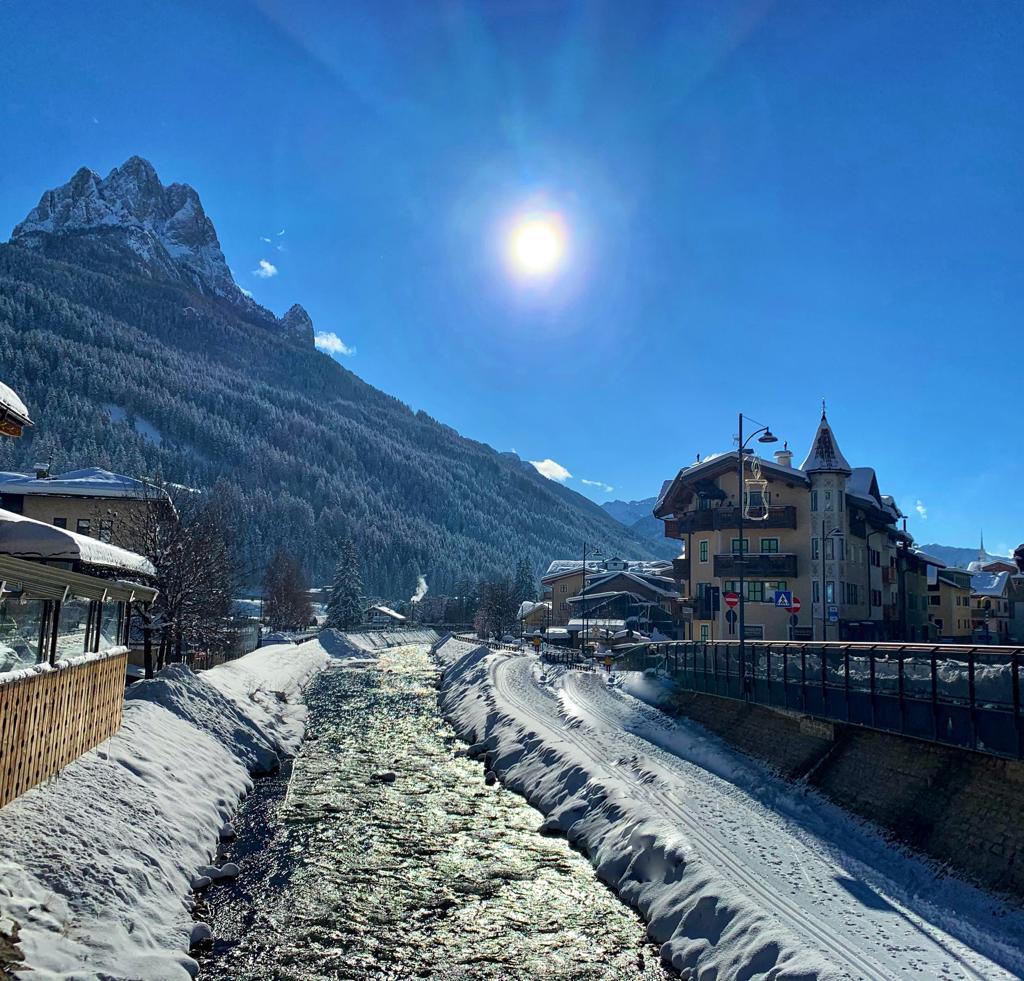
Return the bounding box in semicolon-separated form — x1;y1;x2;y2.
673;692;1024;900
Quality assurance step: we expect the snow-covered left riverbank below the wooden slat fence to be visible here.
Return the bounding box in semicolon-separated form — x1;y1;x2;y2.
0;641;330;981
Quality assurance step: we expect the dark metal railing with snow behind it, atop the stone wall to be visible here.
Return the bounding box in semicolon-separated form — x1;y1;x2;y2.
616;641;1024;759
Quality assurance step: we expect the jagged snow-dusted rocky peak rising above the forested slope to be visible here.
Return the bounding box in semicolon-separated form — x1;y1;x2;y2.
11;157;245;306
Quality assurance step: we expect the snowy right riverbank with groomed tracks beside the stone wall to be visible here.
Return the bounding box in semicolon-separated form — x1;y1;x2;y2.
436;640;1024;981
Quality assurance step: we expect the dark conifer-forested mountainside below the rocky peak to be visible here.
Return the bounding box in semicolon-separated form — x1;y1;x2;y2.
0;243;665;597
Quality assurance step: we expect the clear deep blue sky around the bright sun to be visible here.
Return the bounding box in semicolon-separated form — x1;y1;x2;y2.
0;0;1024;549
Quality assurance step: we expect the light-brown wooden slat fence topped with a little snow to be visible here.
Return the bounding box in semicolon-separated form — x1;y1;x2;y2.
0;647;128;807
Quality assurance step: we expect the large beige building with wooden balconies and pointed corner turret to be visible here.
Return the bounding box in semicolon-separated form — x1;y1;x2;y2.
654;412;905;640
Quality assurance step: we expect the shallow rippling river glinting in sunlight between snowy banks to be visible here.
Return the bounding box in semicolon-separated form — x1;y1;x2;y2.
200;646;669;981
